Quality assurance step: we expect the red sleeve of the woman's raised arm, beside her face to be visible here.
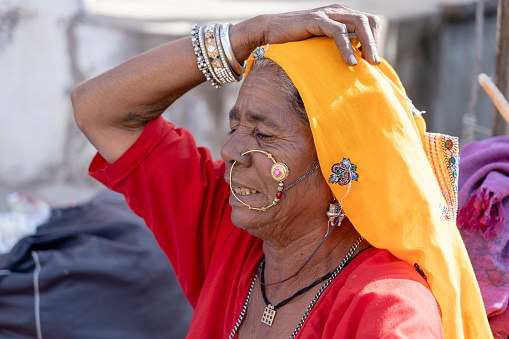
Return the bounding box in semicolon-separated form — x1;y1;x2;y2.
89;117;234;307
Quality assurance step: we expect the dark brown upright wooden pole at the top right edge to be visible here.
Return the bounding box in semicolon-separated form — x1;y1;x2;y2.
492;0;509;136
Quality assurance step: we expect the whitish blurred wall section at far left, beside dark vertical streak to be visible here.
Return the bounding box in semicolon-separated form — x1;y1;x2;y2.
0;0;86;183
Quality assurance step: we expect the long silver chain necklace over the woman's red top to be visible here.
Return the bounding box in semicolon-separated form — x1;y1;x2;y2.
228;236;364;339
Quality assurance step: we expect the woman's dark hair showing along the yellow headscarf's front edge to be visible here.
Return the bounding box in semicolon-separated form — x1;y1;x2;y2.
251;58;309;122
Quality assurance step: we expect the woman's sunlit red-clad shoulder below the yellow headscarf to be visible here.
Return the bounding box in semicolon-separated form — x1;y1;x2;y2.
318;248;443;338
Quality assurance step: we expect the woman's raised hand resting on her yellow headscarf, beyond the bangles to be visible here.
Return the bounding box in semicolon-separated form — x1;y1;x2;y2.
231;5;382;65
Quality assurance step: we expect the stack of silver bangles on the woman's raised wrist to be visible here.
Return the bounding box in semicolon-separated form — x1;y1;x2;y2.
191;23;246;88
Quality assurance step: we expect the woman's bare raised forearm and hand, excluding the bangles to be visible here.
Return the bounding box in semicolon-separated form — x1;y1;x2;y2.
71;5;380;163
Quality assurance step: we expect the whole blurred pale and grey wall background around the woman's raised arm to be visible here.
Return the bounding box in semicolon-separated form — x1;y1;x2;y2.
0;0;507;212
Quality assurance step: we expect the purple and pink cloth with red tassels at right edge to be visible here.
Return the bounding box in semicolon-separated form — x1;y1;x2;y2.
457;136;509;338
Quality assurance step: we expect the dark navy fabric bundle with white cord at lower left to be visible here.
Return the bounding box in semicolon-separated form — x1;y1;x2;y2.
0;192;192;339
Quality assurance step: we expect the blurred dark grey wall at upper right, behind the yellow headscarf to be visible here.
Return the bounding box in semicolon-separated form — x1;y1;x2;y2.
389;6;497;141
